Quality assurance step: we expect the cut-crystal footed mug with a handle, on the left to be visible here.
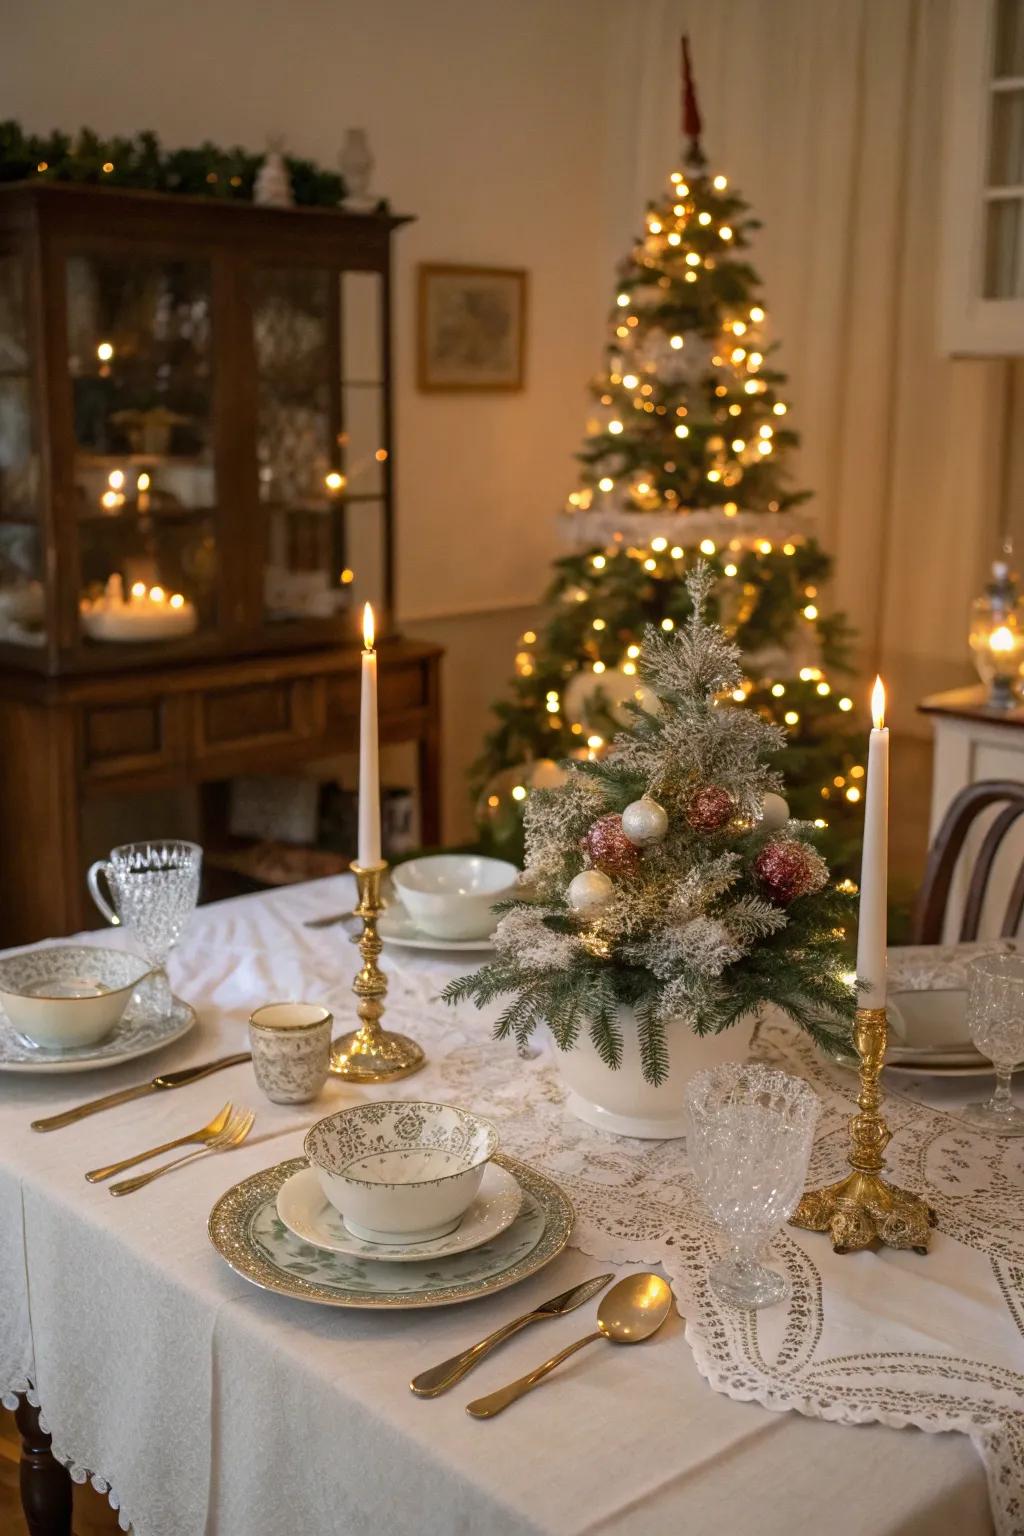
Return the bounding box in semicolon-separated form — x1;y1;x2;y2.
86;837;203;1014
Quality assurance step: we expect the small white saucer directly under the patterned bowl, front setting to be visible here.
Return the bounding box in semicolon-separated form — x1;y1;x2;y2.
278;1163;522;1264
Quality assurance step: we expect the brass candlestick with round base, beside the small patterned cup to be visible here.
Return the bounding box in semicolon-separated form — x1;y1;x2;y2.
330;860;425;1083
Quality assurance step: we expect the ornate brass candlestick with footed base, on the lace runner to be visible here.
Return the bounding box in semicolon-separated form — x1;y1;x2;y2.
791;1008;935;1253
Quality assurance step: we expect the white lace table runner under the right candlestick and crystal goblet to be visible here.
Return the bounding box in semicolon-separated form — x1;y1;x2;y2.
417;951;1024;1536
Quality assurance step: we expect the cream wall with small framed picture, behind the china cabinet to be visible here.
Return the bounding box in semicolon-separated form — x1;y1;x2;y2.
0;0;609;839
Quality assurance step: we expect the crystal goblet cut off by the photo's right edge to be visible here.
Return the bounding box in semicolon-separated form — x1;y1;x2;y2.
964;955;1024;1137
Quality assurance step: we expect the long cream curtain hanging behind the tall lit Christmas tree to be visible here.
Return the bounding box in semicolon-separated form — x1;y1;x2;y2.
608;0;1024;731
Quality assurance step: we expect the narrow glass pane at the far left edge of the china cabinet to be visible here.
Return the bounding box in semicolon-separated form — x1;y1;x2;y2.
0;252;46;647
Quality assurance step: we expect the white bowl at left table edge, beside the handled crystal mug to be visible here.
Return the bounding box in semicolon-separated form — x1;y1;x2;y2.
0;945;152;1051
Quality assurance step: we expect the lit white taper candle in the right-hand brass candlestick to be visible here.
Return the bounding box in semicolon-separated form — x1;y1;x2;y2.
857;677;889;1008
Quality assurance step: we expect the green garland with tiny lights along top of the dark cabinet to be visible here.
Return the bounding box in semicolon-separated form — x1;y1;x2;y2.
0;120;353;207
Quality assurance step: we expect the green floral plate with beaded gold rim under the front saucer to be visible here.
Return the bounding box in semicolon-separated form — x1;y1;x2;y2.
209;1154;574;1307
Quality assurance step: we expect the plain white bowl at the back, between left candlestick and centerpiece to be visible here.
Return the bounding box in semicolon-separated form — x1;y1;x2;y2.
393;854;519;938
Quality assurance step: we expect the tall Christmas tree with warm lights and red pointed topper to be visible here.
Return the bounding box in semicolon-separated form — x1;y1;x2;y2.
474;40;864;868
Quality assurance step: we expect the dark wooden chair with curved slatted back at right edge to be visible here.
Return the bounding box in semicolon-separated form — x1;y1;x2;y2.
912;779;1024;945
